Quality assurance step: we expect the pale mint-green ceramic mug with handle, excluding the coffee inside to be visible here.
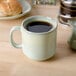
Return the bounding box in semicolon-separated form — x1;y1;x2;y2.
10;16;57;61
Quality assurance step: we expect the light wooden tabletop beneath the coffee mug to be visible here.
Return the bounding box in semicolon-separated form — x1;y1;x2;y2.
0;1;76;76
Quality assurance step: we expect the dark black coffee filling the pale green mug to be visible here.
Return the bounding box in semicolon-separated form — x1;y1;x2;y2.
25;21;53;33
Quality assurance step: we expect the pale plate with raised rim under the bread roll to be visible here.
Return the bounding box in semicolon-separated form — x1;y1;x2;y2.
0;0;31;20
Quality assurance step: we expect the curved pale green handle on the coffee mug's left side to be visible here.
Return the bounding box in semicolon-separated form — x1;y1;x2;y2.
10;26;22;48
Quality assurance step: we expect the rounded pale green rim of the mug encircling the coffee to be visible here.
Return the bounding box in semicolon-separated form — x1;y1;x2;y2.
21;15;58;34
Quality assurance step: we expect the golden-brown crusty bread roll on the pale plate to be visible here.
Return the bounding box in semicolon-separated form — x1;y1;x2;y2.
0;0;22;16
